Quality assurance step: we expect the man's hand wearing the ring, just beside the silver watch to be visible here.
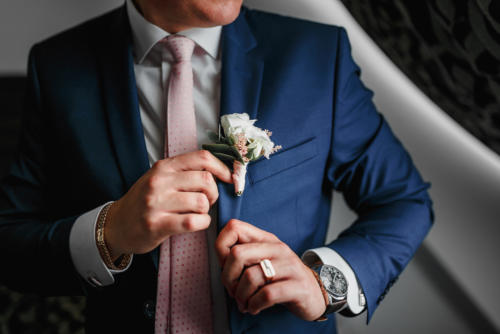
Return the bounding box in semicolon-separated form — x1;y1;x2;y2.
215;219;326;321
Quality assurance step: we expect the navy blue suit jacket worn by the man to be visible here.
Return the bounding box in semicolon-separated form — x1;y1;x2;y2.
0;7;432;333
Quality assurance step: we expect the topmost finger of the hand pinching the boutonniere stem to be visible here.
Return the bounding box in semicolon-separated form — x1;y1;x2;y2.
158;150;233;183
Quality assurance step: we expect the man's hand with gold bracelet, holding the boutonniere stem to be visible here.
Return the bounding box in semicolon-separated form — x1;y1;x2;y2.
104;151;232;260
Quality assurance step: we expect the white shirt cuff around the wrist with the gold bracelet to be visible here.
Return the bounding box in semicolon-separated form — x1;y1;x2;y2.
69;202;132;286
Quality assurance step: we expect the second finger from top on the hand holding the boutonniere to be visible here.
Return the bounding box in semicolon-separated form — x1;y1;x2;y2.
172;171;219;205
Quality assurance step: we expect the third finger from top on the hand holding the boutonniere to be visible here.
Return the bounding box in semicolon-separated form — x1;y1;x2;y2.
160;192;210;213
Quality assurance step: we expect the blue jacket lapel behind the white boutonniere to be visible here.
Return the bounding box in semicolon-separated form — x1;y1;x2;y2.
218;8;264;230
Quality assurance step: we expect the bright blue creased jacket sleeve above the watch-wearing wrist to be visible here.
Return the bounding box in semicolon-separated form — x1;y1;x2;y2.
327;29;433;321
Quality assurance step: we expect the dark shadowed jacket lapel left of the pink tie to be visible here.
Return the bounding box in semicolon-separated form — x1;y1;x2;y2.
99;6;149;193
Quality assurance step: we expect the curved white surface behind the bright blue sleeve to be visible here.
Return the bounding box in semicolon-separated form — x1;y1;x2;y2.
246;0;500;328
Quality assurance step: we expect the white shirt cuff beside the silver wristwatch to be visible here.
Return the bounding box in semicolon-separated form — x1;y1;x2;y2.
302;247;366;315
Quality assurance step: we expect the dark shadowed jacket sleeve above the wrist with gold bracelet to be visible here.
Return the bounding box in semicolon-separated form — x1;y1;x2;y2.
0;46;84;295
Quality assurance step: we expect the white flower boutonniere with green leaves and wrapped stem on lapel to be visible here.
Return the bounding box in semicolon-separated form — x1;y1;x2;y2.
203;113;281;196
